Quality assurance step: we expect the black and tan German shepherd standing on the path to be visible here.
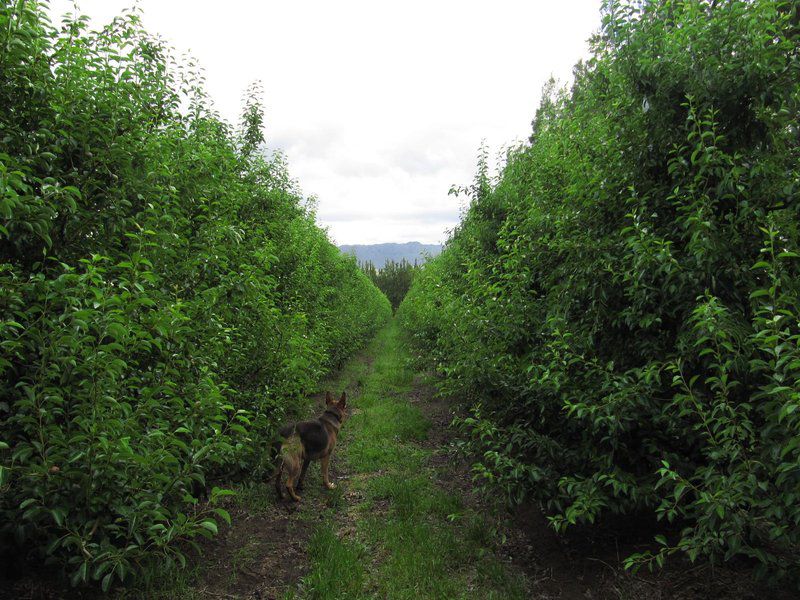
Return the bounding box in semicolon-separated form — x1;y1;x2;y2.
274;392;347;502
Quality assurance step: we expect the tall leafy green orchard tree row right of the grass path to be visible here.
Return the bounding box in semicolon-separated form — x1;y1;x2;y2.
399;0;800;577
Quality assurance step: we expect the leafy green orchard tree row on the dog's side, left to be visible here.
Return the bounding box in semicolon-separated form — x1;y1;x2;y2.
0;1;390;588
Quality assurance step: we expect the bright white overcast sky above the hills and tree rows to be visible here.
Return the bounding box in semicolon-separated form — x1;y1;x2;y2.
50;0;601;244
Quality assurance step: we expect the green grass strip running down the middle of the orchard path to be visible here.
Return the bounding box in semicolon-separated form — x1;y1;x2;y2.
298;323;526;600
